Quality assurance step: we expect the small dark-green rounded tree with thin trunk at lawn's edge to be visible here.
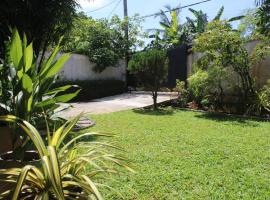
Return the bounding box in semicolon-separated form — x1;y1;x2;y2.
128;49;168;110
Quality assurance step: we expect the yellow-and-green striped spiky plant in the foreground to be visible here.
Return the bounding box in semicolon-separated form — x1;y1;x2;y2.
0;116;133;200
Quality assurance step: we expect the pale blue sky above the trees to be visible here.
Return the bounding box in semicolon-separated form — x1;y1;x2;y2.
79;0;255;30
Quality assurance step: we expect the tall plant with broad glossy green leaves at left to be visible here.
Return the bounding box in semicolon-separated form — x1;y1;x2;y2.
0;29;80;155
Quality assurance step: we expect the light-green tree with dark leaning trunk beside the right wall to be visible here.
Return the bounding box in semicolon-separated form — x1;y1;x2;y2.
193;21;255;108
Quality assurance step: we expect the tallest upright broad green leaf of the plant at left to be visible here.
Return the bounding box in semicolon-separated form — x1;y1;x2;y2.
10;29;23;68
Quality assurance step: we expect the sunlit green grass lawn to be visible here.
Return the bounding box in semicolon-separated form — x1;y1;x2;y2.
86;110;270;200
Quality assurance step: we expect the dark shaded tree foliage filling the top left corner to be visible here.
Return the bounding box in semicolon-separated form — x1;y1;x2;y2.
0;0;79;58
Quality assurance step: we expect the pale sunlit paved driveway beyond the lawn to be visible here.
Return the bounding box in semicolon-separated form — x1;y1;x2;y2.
61;92;177;117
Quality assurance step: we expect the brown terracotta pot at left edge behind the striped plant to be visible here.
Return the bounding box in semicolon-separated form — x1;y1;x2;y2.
0;126;12;154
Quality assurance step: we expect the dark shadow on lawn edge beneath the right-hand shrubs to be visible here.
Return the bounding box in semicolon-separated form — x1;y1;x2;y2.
195;112;266;127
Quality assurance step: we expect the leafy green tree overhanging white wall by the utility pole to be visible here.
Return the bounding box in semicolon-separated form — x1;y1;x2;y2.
64;13;146;72
